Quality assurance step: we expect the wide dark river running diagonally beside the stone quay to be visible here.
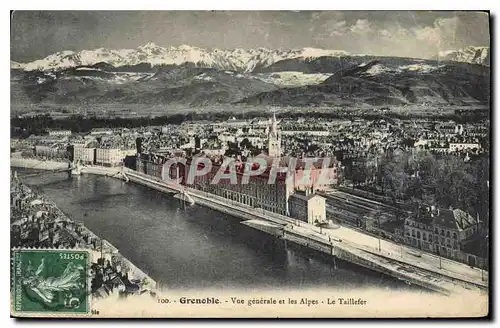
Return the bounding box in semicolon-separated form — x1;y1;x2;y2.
13;169;415;290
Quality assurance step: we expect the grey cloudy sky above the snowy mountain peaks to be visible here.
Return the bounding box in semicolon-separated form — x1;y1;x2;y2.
11;11;490;62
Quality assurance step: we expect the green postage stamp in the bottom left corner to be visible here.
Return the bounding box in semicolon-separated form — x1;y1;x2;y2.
11;249;90;316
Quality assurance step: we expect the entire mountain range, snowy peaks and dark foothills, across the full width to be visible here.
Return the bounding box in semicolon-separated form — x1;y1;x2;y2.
11;44;490;107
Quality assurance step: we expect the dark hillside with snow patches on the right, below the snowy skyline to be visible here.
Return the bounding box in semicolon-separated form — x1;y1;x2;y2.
240;58;490;106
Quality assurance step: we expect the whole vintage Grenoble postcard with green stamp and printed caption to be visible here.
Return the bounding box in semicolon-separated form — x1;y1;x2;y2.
10;11;492;318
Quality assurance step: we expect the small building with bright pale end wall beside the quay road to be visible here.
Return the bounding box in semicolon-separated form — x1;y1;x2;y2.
288;191;326;224
